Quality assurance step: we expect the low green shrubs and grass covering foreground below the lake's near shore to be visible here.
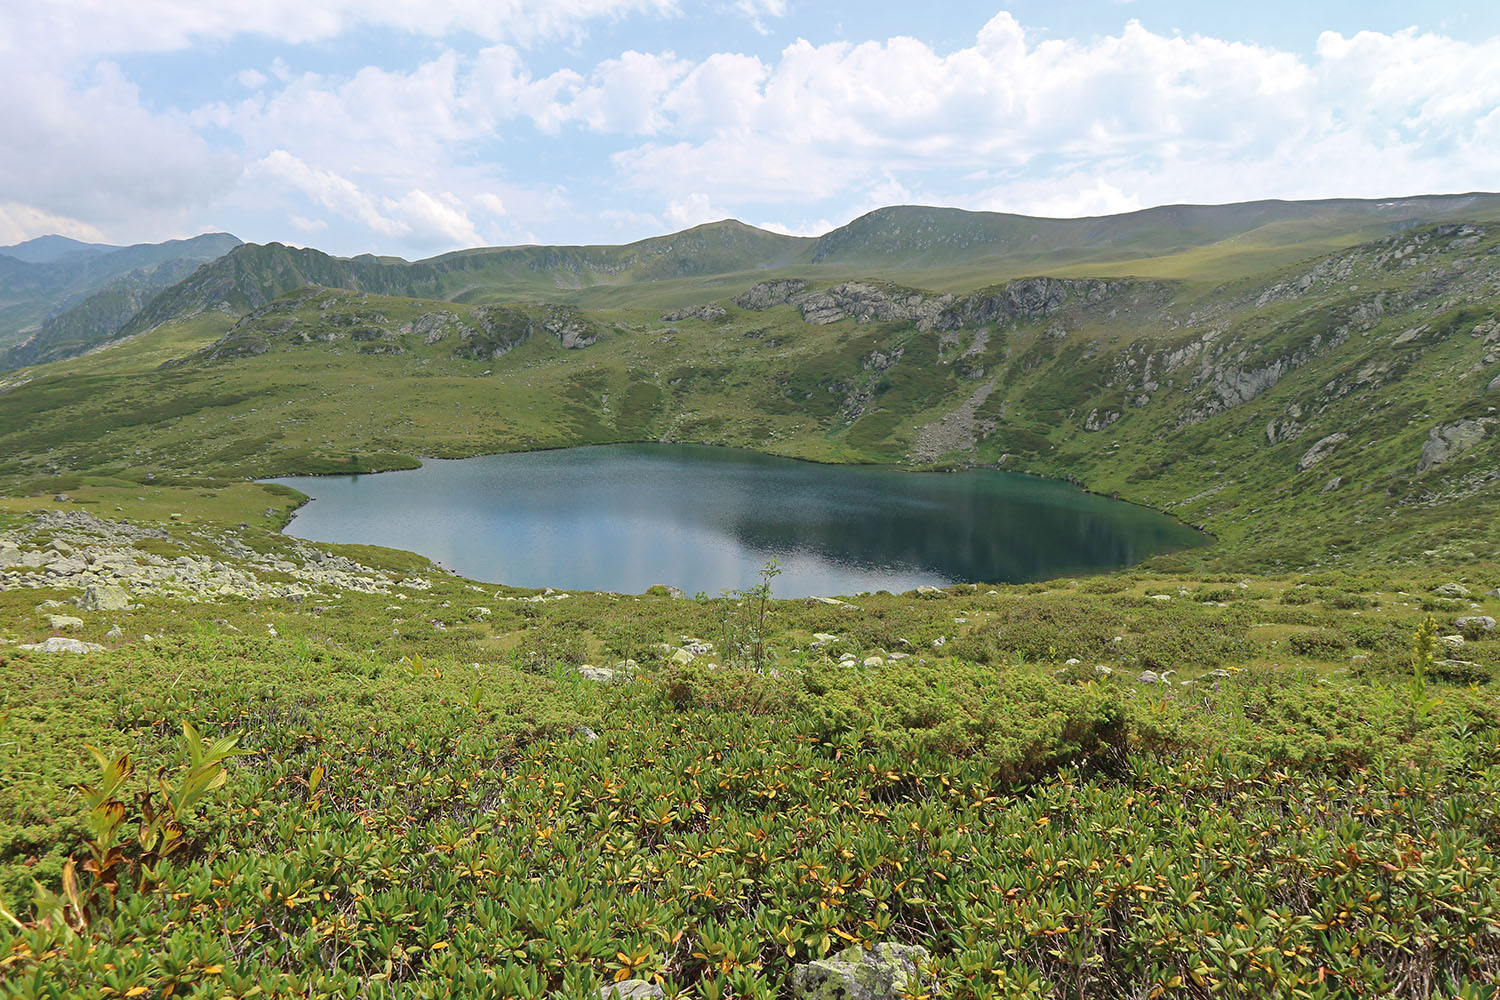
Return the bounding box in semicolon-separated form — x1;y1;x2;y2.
0;542;1500;997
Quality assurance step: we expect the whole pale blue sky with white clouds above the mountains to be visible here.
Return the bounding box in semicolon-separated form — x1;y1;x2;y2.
0;0;1500;259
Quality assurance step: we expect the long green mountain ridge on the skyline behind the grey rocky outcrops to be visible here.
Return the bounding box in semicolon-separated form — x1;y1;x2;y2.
38;192;1500;367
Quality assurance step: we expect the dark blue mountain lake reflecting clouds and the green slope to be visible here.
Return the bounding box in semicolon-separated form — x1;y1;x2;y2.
275;445;1208;597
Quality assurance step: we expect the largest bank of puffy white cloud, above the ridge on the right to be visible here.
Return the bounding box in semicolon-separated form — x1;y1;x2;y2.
597;13;1500;214
